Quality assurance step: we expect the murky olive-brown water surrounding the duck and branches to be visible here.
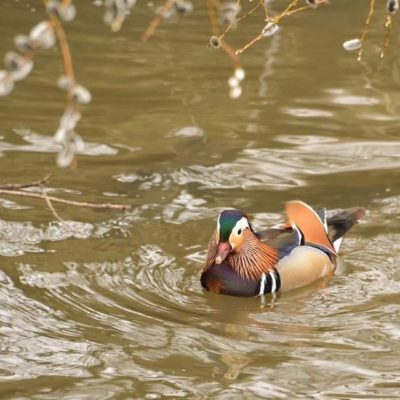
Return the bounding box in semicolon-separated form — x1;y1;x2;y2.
0;0;400;399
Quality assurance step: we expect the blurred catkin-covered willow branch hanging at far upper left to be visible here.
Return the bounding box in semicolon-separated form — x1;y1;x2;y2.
0;0;92;167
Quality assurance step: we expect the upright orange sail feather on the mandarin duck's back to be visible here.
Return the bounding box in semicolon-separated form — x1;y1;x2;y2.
286;200;337;256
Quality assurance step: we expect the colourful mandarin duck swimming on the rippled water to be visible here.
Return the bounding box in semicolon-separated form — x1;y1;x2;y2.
201;200;365;296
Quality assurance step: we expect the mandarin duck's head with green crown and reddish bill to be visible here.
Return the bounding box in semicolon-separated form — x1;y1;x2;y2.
215;210;251;264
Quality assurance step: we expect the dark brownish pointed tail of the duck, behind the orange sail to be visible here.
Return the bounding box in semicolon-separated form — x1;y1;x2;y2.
327;207;365;252
